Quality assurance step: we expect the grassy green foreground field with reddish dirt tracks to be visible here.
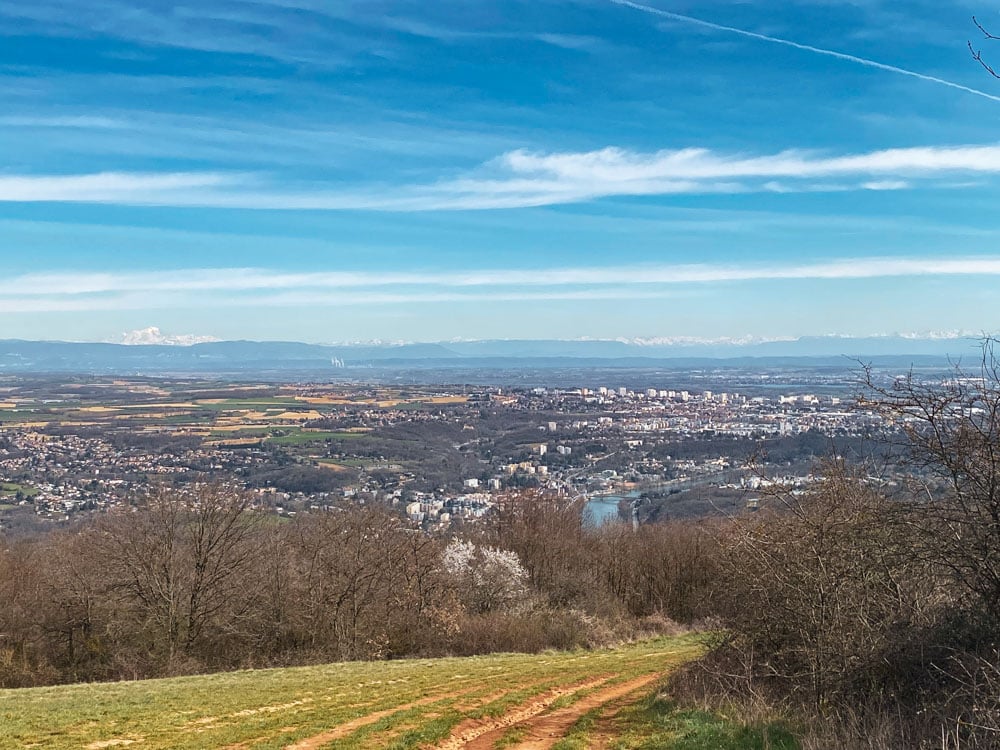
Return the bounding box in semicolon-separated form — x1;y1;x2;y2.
0;636;752;750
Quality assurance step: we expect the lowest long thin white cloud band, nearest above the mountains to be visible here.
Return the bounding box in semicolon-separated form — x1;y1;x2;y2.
0;256;1000;312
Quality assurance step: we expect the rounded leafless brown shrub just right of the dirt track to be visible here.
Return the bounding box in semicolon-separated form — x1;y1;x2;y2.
708;464;938;712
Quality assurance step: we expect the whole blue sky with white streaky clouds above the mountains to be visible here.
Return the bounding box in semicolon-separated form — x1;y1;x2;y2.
0;0;1000;342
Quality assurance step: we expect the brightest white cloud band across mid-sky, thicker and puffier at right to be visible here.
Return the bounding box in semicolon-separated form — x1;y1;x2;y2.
0;145;1000;211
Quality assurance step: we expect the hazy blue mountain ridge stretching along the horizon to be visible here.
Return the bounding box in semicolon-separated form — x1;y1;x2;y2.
0;336;980;375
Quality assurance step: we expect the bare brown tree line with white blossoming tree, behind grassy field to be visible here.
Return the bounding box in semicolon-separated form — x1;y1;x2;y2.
0;486;711;687
